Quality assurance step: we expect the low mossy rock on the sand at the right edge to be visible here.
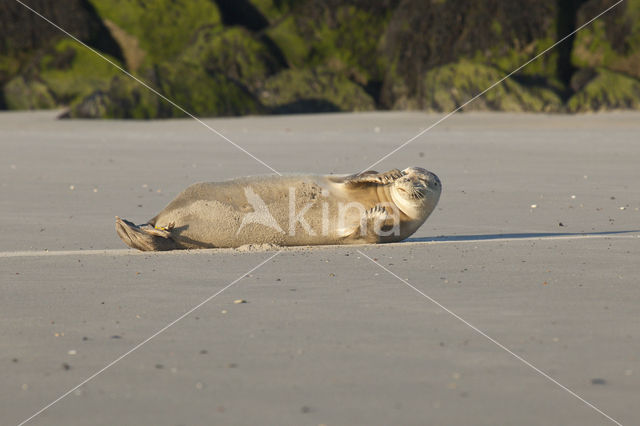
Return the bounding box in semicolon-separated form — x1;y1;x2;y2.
567;68;640;112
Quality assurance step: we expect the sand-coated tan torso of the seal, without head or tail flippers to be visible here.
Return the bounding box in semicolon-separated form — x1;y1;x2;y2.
150;176;375;248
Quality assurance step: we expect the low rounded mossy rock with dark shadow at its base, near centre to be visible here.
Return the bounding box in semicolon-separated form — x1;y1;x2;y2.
260;68;375;114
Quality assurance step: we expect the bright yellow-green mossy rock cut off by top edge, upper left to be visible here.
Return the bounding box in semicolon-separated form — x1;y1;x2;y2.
90;0;221;65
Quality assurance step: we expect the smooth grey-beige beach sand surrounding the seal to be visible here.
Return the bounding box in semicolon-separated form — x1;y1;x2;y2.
0;112;640;425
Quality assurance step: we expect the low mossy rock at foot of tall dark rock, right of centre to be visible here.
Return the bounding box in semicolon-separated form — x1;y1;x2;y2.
412;60;562;112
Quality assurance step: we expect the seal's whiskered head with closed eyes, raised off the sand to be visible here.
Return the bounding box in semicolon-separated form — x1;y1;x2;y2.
390;167;442;220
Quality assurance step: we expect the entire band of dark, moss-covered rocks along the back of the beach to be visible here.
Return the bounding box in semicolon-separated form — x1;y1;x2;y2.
0;0;640;118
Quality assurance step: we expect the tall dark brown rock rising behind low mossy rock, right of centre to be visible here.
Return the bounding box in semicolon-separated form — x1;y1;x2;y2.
381;0;556;109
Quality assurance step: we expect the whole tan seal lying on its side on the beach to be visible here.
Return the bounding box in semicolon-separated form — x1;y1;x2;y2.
116;167;442;251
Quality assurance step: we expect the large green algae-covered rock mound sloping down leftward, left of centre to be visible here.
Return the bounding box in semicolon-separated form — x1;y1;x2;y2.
70;28;280;118
